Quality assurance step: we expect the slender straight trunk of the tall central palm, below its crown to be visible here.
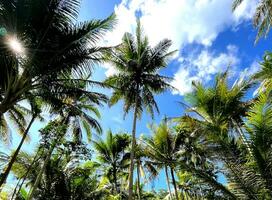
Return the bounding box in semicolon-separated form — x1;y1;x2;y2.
128;96;138;200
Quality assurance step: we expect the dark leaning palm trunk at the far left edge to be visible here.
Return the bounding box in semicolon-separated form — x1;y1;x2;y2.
0;115;36;188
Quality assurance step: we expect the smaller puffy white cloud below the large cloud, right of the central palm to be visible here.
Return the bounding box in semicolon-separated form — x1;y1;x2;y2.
171;45;240;95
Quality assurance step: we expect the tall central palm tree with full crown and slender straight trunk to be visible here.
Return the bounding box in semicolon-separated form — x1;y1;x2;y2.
105;21;174;200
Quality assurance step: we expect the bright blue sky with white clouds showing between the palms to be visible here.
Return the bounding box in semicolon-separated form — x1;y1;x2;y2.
4;0;271;191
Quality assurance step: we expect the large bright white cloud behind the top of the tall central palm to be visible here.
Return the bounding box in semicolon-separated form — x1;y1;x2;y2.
101;0;257;74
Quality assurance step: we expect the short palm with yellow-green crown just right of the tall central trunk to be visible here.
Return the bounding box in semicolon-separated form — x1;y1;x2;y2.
144;119;180;200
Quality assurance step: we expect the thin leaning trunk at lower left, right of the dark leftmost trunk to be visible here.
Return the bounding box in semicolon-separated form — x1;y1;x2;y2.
27;141;57;200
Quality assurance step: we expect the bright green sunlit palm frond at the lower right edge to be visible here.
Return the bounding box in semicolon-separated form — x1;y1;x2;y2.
246;86;272;196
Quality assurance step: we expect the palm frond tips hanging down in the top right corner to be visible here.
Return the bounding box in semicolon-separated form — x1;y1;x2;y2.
232;0;272;42
